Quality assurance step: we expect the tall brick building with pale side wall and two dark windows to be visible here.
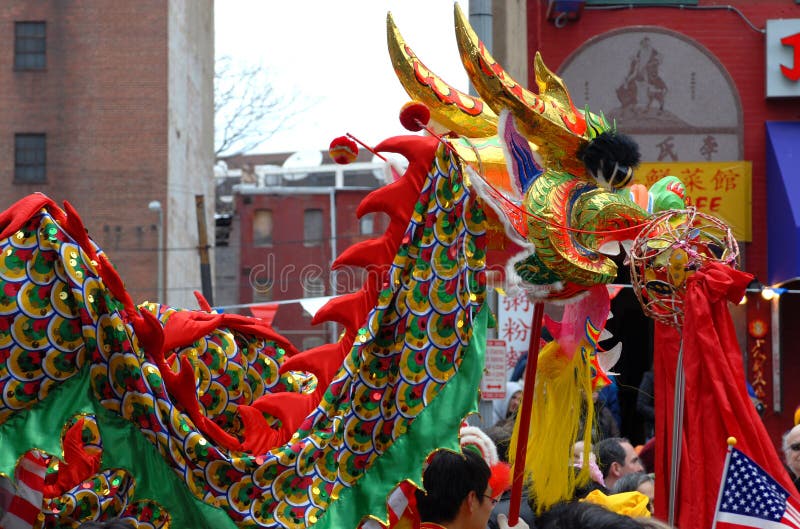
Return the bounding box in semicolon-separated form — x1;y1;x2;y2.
0;0;214;306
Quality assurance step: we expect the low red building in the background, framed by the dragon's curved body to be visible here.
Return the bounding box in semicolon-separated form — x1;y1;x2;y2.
215;152;388;349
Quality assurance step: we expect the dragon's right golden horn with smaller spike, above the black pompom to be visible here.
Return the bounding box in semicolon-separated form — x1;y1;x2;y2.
455;4;588;174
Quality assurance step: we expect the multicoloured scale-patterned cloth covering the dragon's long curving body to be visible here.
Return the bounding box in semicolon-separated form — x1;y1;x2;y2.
0;138;486;527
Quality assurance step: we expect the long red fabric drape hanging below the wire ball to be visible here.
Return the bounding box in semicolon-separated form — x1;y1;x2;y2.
653;262;791;529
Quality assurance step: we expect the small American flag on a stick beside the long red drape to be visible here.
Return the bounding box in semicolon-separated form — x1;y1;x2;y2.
714;448;800;529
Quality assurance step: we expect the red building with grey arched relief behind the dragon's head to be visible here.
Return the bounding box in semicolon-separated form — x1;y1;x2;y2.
527;0;800;439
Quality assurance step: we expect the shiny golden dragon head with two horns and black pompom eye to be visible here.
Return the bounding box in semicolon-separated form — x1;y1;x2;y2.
387;4;680;298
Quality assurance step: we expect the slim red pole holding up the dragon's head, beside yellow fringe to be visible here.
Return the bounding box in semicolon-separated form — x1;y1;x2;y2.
508;301;544;526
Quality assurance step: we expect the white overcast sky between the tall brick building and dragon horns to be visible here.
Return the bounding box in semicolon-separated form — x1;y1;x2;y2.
215;0;469;153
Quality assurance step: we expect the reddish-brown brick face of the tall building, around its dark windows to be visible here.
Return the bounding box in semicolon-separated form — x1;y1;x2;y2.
0;0;167;301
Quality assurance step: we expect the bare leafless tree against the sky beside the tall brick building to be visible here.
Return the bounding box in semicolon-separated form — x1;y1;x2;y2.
214;56;303;158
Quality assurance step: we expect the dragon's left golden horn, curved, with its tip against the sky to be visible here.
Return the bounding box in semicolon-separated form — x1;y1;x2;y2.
386;13;497;138
